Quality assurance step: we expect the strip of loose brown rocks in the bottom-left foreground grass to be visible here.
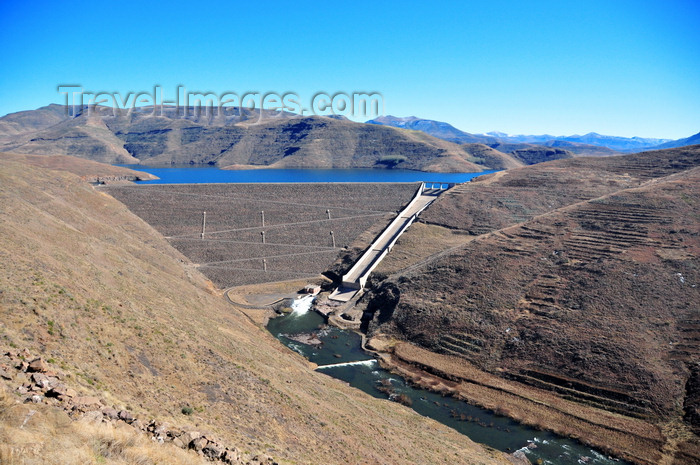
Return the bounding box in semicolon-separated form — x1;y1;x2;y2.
0;349;277;465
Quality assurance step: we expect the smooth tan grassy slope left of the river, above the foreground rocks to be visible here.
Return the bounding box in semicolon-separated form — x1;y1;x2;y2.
0;160;505;464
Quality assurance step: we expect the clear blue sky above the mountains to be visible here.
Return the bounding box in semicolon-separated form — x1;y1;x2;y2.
0;0;700;139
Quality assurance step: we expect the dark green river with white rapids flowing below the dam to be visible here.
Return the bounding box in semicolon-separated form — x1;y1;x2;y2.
267;297;626;465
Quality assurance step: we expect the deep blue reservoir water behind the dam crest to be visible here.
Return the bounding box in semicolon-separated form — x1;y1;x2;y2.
118;165;494;184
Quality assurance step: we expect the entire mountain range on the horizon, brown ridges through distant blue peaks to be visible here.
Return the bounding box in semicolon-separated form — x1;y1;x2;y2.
0;104;700;172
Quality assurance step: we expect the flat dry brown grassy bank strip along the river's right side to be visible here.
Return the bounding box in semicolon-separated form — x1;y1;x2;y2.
366;337;666;465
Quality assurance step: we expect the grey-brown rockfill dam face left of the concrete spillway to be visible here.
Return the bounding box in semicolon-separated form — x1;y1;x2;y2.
104;183;420;288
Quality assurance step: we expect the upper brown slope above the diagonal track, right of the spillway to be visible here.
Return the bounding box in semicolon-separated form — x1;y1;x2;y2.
421;146;700;235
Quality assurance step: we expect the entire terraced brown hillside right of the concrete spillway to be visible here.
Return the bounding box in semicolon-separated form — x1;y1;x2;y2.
369;146;700;464
